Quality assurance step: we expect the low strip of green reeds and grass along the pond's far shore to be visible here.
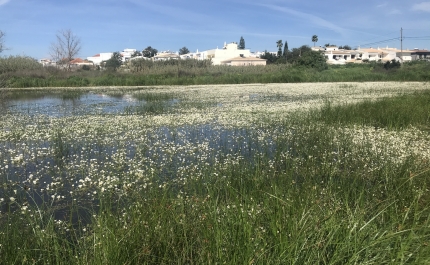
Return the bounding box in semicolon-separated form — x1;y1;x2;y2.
0;58;430;88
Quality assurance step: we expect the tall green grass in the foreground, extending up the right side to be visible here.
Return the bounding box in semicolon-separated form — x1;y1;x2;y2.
0;86;430;264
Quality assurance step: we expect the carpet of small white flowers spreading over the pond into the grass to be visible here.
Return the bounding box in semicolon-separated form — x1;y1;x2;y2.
0;83;430;262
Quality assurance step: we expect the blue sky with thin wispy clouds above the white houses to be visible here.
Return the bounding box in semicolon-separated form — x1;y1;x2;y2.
0;0;430;59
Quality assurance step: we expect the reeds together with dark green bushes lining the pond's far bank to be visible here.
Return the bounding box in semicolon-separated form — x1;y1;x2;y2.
0;54;430;87
